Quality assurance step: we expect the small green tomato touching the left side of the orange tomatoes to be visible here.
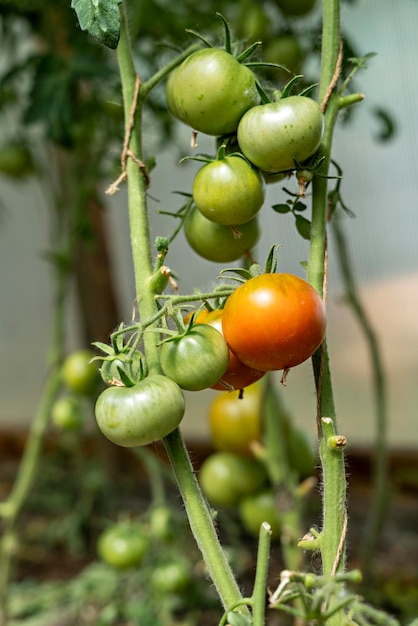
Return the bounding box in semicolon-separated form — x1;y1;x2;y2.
160;324;229;391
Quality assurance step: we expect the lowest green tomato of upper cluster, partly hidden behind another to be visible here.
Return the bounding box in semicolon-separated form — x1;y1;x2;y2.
184;207;260;263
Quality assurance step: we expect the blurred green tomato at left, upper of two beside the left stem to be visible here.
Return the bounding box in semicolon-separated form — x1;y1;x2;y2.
62;350;100;396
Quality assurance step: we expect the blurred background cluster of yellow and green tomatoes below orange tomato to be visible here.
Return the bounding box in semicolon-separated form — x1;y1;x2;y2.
199;382;314;538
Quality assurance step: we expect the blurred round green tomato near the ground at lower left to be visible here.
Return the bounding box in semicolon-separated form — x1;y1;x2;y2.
97;522;149;569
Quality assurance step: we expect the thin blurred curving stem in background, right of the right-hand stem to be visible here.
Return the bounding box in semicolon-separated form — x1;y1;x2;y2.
332;215;388;576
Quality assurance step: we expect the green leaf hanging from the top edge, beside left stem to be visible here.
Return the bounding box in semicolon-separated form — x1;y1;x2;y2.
71;0;120;49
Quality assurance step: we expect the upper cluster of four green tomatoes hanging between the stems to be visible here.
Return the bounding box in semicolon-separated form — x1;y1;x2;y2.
166;41;323;263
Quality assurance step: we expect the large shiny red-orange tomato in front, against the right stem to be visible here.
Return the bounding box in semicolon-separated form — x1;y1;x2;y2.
222;273;326;371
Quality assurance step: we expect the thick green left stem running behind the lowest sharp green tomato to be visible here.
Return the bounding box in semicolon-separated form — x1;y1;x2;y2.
118;8;248;612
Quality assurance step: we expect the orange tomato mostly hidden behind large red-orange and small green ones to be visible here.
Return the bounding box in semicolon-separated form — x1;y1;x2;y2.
195;309;265;391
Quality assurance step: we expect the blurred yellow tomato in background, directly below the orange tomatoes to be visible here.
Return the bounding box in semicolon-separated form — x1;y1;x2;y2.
209;383;261;455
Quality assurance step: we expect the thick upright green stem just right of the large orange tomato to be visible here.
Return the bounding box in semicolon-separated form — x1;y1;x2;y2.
308;0;347;626
